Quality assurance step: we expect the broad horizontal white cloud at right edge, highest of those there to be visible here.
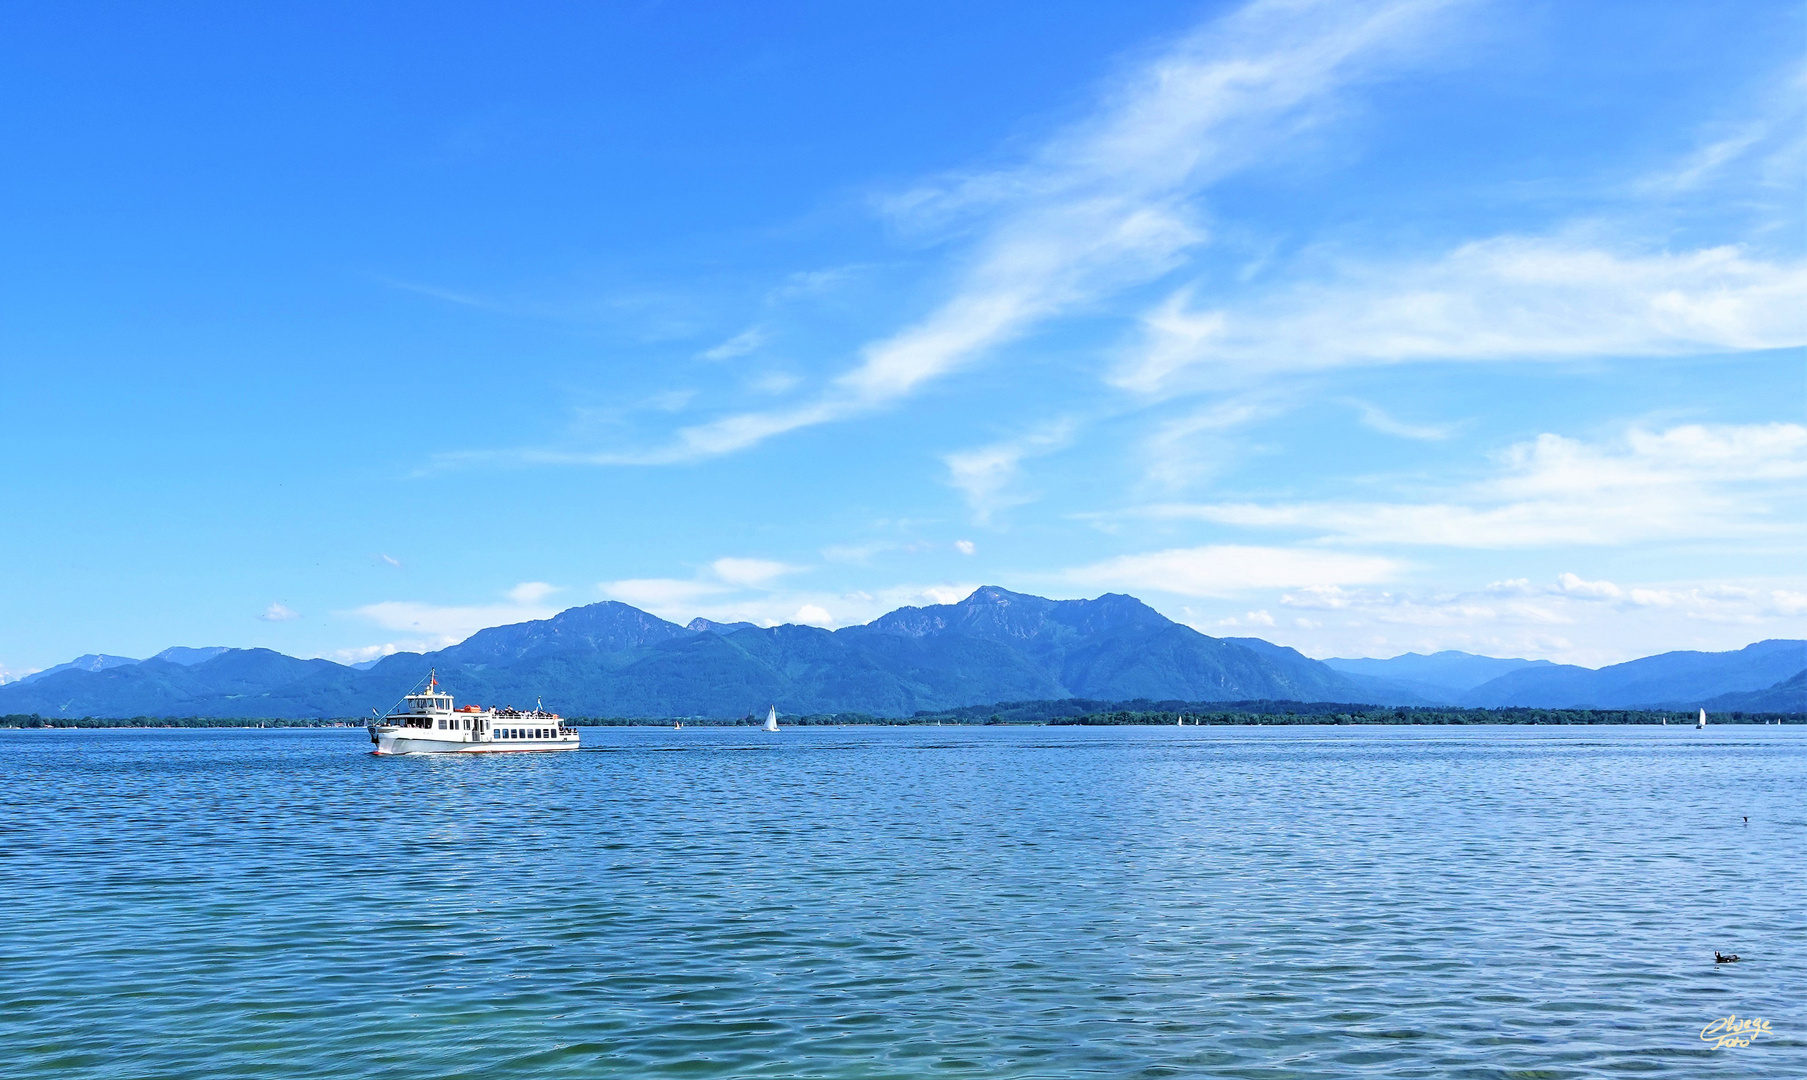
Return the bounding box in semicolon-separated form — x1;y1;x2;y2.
1113;237;1807;394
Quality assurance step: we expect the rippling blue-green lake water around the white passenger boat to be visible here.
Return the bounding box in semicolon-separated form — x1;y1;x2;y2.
0;726;1807;1080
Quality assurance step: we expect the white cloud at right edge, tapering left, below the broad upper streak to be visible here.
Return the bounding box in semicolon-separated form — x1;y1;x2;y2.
1144;423;1807;549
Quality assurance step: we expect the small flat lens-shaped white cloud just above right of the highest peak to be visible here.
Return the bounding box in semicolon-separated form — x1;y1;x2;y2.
1063;544;1399;596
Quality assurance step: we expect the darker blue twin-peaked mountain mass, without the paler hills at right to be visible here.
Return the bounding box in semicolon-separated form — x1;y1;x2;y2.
0;587;1395;717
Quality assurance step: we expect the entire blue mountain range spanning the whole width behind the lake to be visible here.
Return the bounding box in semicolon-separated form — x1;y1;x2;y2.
0;585;1807;719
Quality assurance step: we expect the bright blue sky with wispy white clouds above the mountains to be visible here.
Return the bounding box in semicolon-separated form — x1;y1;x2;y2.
0;0;1807;675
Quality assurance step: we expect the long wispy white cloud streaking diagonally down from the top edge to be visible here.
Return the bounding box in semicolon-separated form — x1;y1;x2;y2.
657;0;1449;461
